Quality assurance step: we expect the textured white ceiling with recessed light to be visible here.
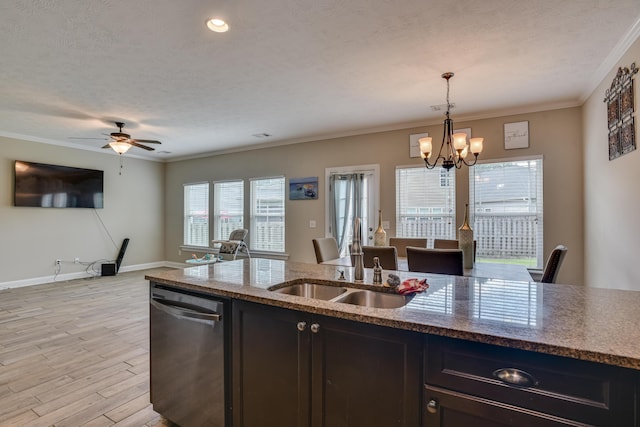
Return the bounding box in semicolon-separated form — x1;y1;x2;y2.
0;0;640;160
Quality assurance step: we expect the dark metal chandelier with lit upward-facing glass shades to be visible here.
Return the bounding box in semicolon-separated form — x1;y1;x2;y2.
418;73;484;170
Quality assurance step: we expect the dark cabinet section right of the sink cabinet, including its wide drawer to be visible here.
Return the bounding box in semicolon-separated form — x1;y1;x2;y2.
423;336;638;427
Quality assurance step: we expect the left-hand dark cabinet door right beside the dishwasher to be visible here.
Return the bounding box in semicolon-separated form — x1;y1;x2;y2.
232;301;311;427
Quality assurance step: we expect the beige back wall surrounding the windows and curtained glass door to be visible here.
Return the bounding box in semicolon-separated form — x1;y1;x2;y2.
165;108;583;283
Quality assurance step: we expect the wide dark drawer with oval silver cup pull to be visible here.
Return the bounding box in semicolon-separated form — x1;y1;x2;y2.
425;336;638;427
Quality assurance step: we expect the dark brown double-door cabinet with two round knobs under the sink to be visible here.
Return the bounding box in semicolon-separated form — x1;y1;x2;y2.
232;301;422;427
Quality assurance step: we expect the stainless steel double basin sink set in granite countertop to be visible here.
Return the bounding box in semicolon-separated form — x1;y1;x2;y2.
273;282;412;308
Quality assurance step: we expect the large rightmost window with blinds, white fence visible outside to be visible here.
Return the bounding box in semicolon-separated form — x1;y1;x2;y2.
469;157;544;269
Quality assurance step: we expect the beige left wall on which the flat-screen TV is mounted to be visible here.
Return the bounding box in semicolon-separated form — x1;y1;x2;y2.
0;137;165;287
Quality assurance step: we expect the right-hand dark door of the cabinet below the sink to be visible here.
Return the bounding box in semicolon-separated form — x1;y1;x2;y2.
311;316;422;427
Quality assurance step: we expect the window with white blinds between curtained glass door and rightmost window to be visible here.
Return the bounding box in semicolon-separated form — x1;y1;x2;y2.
396;166;456;244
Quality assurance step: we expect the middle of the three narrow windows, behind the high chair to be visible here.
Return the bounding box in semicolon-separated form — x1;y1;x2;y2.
213;181;244;240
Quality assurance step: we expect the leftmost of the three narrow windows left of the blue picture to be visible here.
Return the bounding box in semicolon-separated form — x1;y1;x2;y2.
184;182;209;246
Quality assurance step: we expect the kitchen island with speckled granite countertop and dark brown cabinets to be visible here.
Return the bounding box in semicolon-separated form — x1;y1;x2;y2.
147;259;640;427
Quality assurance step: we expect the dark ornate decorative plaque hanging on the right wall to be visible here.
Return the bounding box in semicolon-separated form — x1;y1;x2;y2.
604;62;638;160
